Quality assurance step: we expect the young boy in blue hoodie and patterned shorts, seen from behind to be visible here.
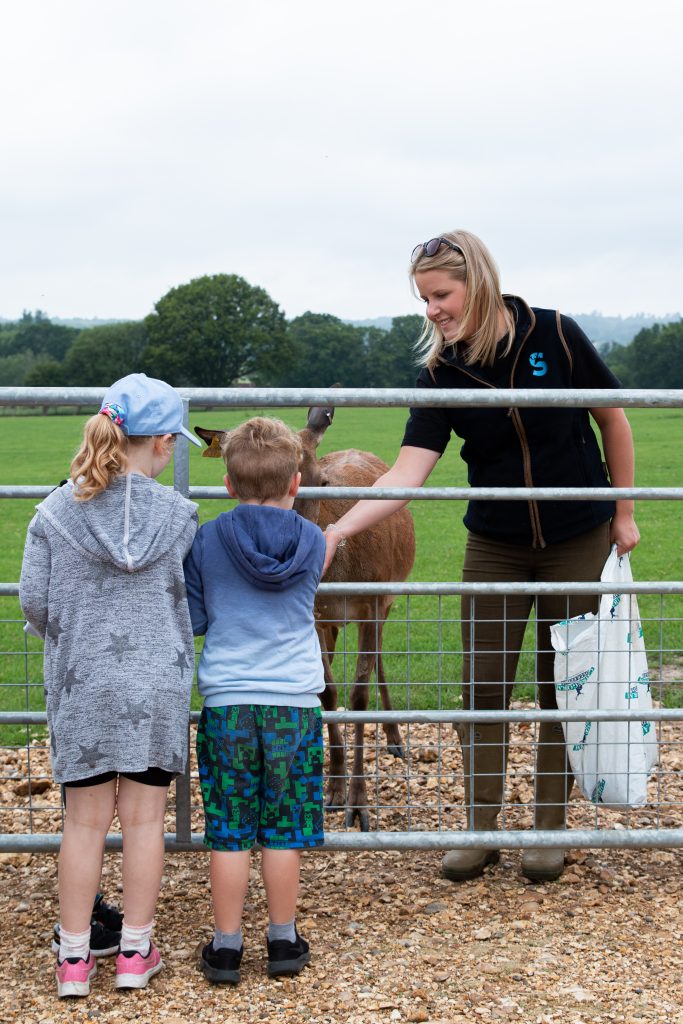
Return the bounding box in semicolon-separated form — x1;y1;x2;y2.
185;417;325;984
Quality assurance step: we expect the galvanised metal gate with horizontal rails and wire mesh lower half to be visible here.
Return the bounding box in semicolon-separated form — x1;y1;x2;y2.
0;388;683;851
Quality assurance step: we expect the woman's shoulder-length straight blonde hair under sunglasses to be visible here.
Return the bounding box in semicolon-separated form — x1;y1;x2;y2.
410;229;514;370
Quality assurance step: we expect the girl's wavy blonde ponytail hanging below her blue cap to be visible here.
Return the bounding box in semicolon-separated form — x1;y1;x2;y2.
70;413;150;502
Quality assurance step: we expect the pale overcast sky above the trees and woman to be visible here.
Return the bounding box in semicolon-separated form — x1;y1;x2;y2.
0;0;683;318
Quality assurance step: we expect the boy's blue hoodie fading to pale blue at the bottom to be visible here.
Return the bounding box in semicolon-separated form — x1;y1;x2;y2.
184;505;325;708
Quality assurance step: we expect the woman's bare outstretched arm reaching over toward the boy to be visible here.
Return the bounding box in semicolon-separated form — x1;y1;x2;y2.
323;444;440;575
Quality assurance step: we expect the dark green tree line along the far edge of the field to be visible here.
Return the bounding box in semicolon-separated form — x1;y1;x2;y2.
0;273;683;388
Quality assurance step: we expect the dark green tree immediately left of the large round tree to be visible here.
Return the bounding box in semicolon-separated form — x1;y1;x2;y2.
65;321;146;387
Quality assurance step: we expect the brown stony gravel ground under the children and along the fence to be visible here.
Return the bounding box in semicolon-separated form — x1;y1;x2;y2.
0;727;683;1024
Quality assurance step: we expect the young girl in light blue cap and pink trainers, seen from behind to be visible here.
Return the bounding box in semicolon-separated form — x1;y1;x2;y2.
19;374;199;996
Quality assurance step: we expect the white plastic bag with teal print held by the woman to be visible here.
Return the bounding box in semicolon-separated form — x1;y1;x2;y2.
550;545;657;808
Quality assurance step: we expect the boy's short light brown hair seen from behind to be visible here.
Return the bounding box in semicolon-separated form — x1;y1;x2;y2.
220;416;303;501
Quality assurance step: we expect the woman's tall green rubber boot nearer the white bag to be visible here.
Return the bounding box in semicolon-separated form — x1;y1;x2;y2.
522;722;573;882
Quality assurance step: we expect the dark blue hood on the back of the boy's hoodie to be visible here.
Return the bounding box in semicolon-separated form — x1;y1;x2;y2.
216;505;321;590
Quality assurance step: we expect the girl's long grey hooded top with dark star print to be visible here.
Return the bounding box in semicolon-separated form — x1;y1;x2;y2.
19;473;198;782
